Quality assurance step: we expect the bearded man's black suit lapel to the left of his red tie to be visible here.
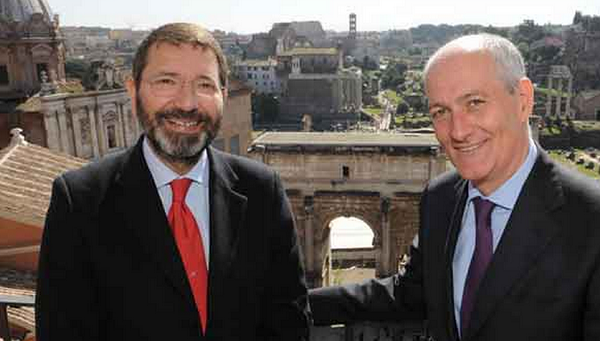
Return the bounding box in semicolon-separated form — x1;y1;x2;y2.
117;138;196;311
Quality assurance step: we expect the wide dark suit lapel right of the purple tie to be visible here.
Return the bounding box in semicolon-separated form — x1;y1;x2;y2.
465;149;564;337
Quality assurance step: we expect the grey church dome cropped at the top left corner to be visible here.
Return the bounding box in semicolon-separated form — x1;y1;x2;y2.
0;0;53;23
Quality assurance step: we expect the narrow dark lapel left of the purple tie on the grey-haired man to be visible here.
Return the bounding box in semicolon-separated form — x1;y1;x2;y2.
445;180;467;340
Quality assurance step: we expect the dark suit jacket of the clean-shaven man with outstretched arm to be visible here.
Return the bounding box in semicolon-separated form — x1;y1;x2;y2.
309;148;600;341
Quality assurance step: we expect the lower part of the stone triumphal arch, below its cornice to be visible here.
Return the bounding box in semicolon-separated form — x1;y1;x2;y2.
288;191;419;287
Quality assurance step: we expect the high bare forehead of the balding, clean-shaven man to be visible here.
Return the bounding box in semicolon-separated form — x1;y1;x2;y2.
425;50;502;100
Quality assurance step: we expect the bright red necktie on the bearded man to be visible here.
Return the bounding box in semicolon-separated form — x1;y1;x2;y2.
169;179;208;333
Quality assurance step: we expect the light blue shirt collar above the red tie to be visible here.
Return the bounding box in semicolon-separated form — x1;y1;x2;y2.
142;137;208;188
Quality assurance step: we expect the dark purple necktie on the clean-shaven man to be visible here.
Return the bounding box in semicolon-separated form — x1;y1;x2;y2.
460;197;494;336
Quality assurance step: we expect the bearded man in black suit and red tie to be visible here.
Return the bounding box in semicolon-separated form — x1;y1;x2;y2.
36;23;309;341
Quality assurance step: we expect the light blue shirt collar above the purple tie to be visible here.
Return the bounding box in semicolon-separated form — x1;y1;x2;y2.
468;138;538;210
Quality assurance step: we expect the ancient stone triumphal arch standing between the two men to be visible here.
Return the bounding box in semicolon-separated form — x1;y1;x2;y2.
249;132;447;287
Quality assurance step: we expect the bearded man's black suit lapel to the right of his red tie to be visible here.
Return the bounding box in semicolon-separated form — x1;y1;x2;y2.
208;148;247;314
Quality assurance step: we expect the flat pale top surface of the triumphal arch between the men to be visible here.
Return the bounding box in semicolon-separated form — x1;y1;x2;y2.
252;132;439;149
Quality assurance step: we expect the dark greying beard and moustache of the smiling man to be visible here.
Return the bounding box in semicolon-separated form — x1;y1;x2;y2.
136;96;223;165
